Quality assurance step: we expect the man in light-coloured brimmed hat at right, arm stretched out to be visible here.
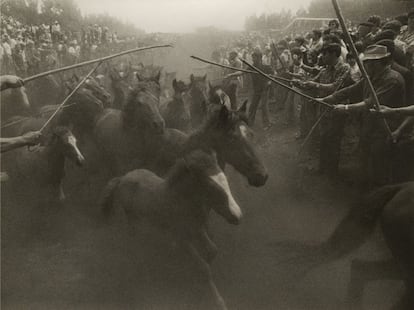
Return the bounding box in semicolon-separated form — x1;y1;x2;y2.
323;45;405;186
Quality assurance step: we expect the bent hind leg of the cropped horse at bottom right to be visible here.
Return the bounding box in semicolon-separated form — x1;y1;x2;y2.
348;258;401;309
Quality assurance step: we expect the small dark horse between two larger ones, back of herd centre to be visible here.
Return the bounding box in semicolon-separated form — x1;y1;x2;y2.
163;79;191;132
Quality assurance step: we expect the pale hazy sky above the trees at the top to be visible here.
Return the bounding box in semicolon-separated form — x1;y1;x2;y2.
76;0;311;32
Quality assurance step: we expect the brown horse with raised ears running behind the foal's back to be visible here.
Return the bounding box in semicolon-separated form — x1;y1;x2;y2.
94;83;165;176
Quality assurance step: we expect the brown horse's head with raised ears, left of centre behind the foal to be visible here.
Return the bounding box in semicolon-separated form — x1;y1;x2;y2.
123;85;165;134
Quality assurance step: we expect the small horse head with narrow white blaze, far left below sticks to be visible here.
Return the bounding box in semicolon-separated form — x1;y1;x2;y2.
48;126;85;166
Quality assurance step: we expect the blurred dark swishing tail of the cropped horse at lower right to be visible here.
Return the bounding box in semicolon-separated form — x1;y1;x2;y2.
323;184;404;260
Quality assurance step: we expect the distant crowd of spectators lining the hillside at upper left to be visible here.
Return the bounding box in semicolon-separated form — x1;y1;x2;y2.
0;15;139;77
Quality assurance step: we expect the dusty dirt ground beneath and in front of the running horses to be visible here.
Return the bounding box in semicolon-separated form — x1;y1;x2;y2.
1;107;402;310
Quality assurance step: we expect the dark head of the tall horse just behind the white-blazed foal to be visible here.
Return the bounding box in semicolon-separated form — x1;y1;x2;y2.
200;101;268;187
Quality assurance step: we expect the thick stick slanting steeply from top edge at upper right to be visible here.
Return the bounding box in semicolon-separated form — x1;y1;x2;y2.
332;0;392;137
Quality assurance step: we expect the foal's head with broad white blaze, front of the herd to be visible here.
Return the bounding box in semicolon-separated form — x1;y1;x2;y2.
177;149;242;225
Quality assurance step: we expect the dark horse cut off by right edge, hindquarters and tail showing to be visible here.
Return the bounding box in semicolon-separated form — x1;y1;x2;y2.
272;182;414;310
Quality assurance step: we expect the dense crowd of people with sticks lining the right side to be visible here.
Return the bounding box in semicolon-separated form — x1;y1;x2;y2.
210;10;414;187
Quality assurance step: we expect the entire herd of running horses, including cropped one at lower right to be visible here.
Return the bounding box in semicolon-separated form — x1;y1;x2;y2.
2;64;414;309
